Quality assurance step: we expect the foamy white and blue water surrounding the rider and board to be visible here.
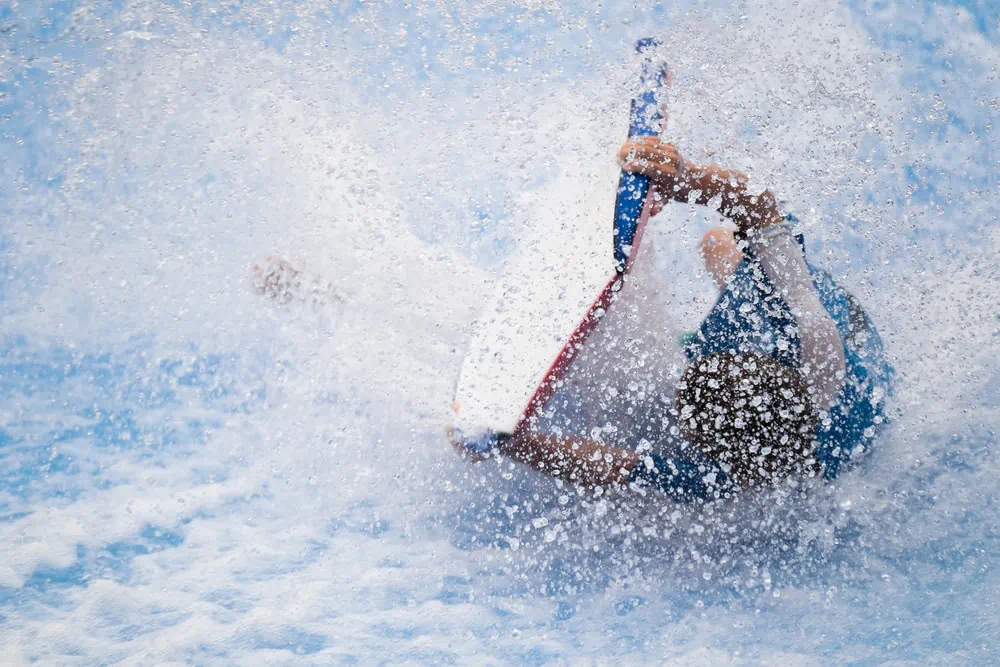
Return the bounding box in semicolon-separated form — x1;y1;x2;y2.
0;1;1000;665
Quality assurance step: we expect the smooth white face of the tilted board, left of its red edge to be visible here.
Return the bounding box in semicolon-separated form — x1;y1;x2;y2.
452;163;617;433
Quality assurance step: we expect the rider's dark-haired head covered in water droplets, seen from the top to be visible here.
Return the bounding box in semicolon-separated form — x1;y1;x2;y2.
676;353;818;486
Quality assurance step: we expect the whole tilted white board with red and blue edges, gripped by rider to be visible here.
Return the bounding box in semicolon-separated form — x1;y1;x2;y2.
452;40;672;444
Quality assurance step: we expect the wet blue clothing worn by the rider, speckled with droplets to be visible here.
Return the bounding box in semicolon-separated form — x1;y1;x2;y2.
629;227;894;502
